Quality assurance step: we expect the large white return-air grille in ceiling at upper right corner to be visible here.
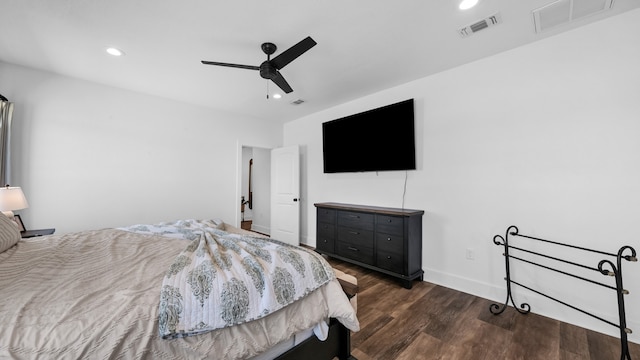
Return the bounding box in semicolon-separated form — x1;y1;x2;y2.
533;0;613;33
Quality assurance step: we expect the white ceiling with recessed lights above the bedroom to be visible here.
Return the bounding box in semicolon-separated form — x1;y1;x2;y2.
0;0;640;122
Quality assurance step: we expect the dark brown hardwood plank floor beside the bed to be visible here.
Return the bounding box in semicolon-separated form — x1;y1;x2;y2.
329;259;640;360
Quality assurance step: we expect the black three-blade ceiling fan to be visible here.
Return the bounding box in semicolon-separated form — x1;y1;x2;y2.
202;36;317;94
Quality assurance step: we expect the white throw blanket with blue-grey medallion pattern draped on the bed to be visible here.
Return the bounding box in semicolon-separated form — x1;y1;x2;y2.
121;220;335;338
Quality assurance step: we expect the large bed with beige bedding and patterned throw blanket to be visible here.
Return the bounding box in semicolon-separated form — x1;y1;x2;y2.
0;215;359;359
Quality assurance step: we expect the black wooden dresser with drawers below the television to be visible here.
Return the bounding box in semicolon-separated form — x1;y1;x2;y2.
314;203;424;289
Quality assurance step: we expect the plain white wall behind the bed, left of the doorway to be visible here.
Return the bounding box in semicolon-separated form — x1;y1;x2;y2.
0;63;282;233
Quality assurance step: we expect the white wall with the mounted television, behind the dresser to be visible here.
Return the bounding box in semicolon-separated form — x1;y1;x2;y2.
284;10;640;342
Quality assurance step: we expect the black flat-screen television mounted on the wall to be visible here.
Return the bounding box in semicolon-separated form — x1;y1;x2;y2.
322;99;416;173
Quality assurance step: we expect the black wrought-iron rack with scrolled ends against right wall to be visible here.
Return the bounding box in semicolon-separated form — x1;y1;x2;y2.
489;225;638;360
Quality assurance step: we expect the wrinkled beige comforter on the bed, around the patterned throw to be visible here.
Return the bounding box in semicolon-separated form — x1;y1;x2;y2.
0;221;359;359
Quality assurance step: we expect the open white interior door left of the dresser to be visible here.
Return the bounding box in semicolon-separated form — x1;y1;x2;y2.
271;145;300;245
